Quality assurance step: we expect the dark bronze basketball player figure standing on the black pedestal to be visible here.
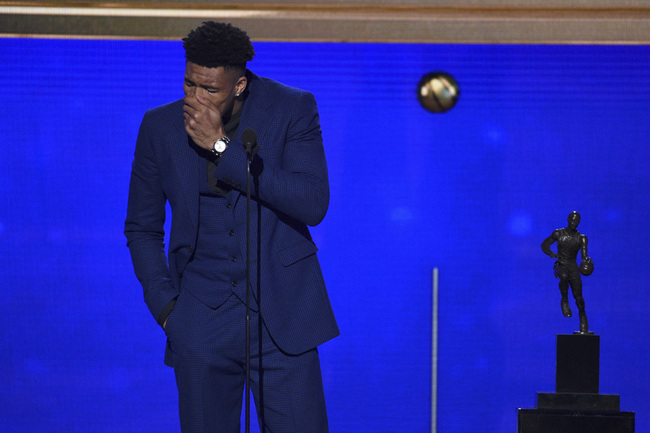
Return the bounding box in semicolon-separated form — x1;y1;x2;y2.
542;212;594;334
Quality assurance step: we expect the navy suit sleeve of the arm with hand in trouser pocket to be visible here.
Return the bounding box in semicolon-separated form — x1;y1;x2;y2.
124;113;178;325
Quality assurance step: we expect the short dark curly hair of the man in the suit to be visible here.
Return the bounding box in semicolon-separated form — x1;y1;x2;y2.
183;21;255;72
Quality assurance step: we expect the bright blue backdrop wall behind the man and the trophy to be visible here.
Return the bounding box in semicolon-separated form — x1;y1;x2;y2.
0;39;650;433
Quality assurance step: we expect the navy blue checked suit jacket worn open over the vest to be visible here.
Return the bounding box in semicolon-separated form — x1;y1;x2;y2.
125;73;339;354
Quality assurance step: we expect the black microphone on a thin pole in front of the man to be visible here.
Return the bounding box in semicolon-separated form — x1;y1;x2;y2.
241;128;259;433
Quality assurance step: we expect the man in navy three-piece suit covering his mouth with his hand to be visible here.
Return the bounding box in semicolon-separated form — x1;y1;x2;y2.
125;22;339;433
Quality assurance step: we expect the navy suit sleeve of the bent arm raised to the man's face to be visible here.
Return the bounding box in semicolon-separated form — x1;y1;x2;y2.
215;91;330;226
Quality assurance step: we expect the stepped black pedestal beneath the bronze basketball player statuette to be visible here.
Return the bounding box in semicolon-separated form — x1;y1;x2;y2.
518;334;634;433
